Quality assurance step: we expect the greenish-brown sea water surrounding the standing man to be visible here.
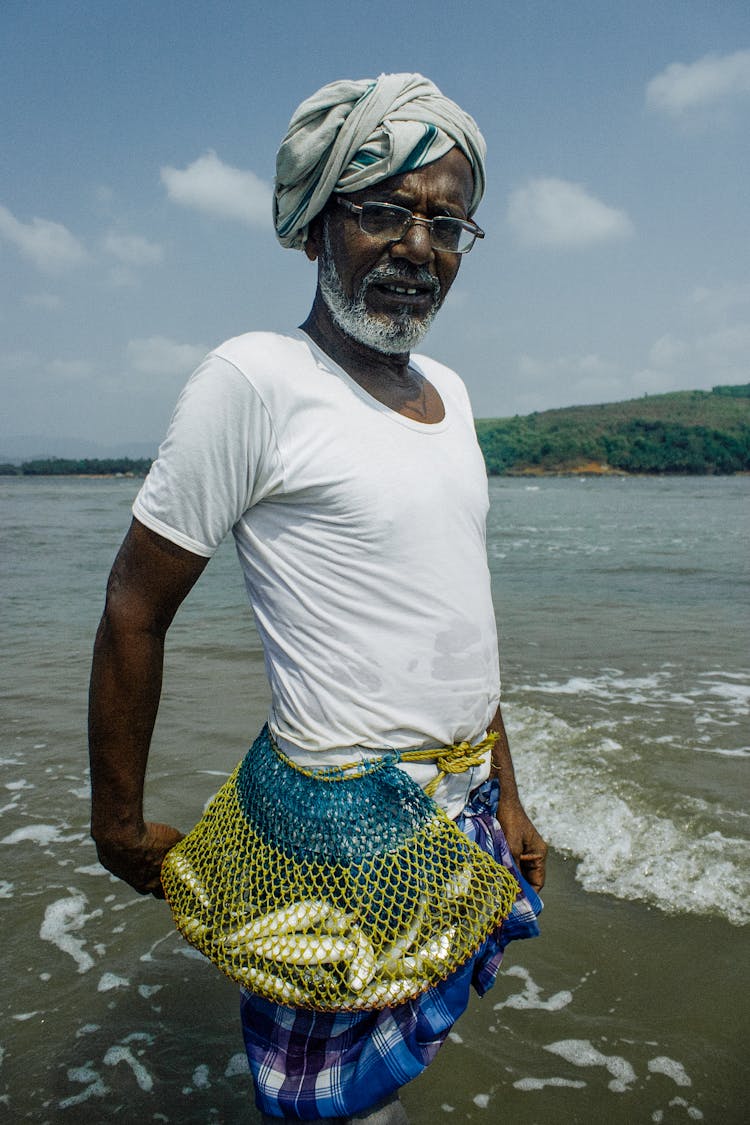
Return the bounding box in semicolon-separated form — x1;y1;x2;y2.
0;477;750;1125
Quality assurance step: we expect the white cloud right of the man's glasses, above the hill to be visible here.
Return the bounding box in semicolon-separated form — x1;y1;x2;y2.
507;177;633;246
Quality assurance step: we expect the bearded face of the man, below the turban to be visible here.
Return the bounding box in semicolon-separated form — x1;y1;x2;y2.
308;149;473;353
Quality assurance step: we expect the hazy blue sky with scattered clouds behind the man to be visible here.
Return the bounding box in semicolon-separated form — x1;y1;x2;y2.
0;0;750;459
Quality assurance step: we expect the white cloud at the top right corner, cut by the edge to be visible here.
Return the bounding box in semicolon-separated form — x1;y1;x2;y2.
645;51;750;118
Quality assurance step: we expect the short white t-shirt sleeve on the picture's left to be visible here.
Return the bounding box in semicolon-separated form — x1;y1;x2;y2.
133;354;282;558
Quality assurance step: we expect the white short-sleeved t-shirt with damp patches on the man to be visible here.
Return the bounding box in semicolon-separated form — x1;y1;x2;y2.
133;330;499;811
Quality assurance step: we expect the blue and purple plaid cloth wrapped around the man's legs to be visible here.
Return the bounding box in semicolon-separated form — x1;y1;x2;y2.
241;779;542;1121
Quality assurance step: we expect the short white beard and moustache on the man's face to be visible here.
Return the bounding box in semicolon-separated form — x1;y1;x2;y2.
318;221;440;356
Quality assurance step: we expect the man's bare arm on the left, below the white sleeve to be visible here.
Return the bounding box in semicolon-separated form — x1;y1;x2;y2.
89;520;208;898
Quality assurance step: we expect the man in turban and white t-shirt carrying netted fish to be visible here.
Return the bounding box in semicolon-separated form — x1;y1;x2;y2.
90;74;546;1125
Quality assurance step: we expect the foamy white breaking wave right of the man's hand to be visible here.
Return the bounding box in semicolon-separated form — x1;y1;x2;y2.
506;705;750;925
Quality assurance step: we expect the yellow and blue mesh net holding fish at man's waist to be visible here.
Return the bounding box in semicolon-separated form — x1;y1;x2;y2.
162;730;518;1011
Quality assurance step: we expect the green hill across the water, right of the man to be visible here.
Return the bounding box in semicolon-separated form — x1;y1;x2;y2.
477;384;750;475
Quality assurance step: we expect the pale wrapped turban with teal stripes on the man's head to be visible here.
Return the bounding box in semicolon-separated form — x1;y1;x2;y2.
273;74;487;250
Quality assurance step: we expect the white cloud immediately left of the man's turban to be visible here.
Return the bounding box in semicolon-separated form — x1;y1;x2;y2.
161;152;271;226
